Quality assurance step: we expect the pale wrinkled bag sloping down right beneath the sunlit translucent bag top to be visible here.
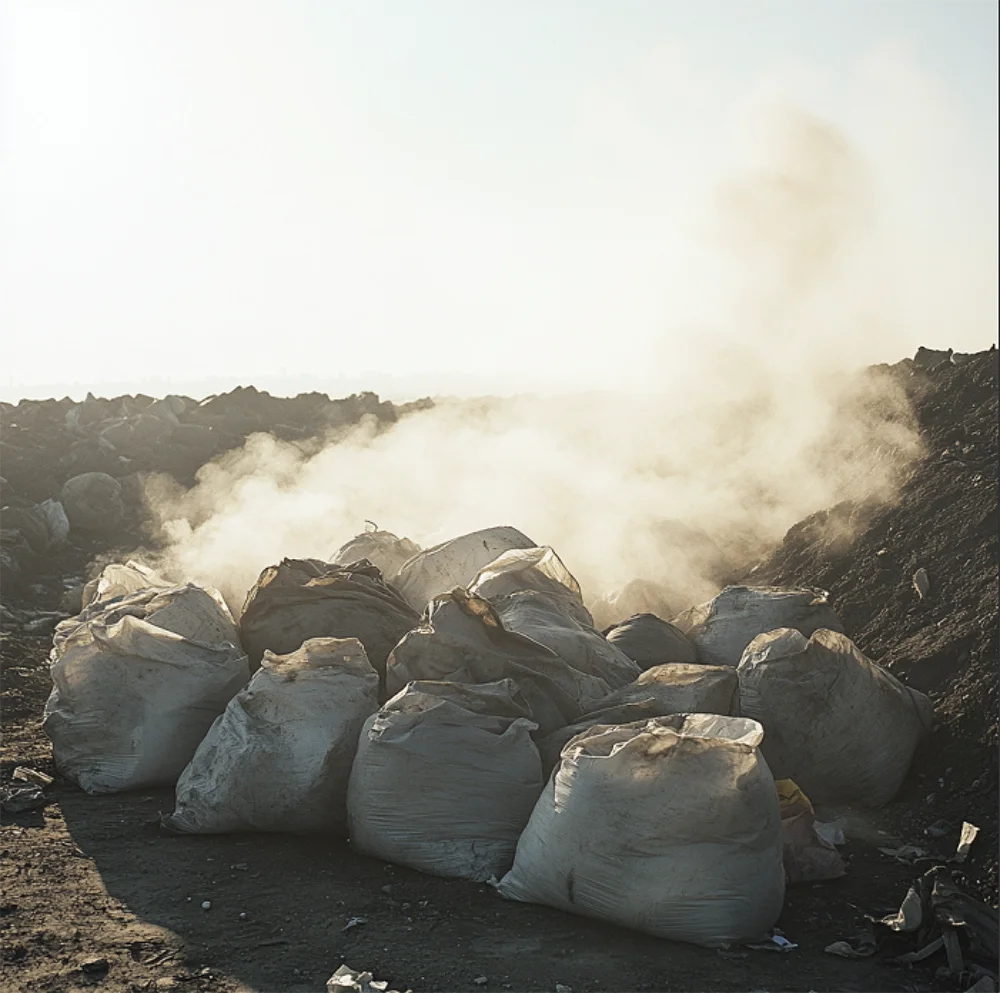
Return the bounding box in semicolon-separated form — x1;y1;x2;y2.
493;590;640;690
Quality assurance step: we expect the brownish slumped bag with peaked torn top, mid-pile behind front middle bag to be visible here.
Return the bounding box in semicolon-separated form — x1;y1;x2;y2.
386;589;611;734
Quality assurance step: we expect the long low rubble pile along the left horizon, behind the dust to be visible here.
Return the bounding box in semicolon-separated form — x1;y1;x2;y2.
0;386;406;588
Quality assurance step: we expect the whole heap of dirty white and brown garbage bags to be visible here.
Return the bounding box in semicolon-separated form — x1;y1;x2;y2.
37;527;933;945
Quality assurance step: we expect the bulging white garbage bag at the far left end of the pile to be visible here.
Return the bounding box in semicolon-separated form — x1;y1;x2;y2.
42;586;250;793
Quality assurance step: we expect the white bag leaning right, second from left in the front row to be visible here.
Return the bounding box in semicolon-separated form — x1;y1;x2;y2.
164;638;378;834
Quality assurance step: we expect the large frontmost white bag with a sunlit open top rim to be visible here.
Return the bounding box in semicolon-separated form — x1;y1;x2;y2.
499;714;785;946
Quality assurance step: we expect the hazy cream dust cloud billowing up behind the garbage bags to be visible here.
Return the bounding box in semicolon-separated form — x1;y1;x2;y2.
141;108;919;611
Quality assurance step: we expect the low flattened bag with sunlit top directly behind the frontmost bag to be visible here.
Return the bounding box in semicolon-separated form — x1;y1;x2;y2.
538;663;740;774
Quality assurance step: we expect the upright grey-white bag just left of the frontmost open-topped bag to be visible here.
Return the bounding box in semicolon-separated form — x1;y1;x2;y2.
347;679;542;882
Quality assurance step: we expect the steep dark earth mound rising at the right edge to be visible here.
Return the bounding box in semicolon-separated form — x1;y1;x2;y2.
747;348;998;900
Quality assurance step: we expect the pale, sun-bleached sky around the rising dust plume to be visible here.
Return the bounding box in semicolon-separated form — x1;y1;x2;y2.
0;0;997;400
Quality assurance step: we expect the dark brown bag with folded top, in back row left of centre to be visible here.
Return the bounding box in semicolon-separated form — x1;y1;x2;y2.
240;559;420;674
